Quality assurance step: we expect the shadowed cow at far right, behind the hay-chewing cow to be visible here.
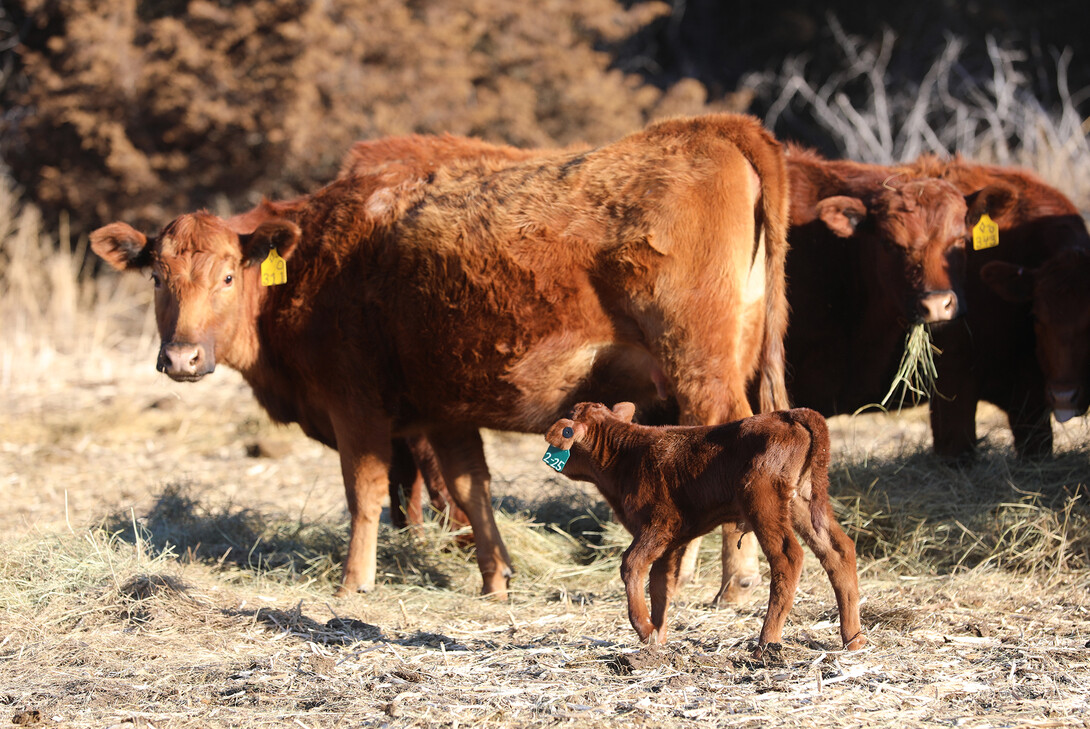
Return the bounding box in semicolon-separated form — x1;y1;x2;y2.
913;155;1090;458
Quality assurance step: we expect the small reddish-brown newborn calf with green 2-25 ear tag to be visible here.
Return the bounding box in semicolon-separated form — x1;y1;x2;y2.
545;402;867;657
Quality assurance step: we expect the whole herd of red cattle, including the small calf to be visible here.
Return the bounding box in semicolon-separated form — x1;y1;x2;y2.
92;114;1090;653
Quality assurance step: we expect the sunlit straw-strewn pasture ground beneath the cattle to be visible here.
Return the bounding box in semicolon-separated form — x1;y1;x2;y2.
0;346;1090;729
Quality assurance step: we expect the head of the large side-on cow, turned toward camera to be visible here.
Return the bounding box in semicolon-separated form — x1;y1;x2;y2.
90;212;300;381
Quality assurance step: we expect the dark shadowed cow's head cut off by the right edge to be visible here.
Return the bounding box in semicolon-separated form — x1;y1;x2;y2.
980;248;1090;423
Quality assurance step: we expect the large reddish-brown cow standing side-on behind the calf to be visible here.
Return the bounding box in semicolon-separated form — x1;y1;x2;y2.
92;114;788;598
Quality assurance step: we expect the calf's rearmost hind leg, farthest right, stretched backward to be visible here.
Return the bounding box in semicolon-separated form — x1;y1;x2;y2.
792;498;867;651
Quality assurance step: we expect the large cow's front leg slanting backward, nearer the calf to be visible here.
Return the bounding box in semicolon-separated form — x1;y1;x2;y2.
429;428;513;599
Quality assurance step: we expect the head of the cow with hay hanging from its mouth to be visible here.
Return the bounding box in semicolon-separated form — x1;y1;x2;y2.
816;178;1007;324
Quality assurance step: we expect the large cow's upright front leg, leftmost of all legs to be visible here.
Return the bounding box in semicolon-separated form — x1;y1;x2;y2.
334;415;391;596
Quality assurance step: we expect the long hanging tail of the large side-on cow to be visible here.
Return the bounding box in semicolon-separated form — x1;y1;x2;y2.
734;117;790;412
